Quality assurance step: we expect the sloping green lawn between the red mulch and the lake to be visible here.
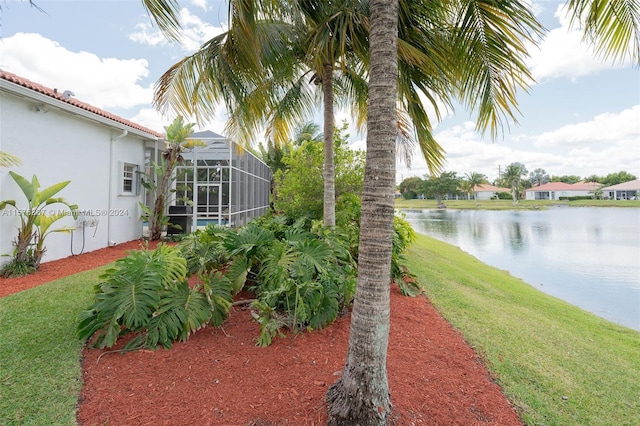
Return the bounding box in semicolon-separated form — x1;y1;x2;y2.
409;236;640;425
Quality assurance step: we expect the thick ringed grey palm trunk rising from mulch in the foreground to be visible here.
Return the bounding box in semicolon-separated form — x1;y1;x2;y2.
327;0;398;425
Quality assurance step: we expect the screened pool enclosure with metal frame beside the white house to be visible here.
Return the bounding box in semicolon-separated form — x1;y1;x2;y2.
175;130;271;227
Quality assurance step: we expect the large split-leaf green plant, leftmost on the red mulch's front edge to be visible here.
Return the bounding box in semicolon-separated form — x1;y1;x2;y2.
78;244;233;350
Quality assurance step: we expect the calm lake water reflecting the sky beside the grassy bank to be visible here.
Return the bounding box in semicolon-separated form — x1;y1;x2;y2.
403;207;640;330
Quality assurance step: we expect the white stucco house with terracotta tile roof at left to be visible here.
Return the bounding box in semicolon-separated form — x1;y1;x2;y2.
0;69;163;263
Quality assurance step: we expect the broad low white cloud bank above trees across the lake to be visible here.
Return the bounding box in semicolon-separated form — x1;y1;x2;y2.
397;105;640;182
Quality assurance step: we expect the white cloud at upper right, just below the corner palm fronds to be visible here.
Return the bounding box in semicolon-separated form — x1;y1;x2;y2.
527;4;628;82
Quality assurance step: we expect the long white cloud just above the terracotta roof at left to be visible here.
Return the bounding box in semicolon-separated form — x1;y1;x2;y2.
0;33;153;109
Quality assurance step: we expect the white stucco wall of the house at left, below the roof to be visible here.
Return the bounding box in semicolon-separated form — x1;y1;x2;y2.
0;92;152;264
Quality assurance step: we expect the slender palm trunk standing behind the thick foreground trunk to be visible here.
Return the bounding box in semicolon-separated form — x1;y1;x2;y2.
322;64;336;226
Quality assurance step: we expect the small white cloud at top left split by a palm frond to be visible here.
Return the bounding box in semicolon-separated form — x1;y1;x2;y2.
129;7;225;52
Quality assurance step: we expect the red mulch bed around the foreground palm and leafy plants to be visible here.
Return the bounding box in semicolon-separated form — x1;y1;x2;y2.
0;241;522;426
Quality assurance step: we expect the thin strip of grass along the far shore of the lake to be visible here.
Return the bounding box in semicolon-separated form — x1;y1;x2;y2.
396;198;640;210
